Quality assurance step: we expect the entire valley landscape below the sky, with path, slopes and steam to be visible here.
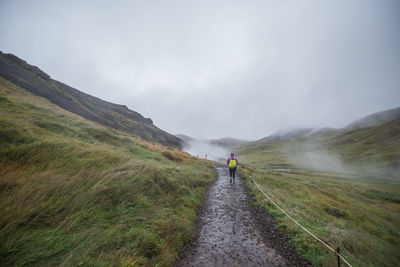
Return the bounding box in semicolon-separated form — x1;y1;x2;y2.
0;53;400;266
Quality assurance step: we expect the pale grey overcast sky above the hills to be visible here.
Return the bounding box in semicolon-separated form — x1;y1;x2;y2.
0;0;400;140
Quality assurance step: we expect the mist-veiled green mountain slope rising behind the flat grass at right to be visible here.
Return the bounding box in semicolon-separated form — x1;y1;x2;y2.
240;108;400;176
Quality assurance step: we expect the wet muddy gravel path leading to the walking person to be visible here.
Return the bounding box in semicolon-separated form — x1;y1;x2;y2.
177;167;309;266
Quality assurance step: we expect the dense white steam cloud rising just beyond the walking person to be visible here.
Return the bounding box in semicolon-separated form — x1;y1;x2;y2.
182;140;230;161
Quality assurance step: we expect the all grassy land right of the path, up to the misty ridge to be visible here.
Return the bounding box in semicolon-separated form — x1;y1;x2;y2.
238;110;400;266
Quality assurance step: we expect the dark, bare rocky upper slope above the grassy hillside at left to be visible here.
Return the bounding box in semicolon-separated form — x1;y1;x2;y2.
0;52;181;147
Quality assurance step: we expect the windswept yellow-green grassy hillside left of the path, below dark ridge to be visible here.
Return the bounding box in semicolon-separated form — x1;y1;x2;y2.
0;77;215;266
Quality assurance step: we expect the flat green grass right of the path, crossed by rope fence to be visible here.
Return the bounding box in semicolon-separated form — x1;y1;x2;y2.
240;164;400;266
